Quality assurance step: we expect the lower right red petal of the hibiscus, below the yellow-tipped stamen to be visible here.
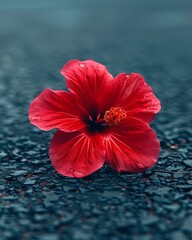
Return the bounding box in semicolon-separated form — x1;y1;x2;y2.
105;118;160;173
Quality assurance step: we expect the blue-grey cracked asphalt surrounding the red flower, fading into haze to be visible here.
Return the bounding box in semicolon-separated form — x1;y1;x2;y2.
0;0;192;240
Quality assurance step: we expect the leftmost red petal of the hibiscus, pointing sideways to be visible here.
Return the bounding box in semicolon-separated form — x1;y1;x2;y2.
29;89;85;132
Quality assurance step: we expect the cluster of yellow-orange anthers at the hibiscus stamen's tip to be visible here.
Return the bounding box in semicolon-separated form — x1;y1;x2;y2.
104;107;127;125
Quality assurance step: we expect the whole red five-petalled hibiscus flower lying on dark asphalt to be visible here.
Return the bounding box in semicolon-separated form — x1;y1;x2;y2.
29;60;160;178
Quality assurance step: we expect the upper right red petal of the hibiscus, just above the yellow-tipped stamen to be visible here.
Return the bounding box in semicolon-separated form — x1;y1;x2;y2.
106;73;161;123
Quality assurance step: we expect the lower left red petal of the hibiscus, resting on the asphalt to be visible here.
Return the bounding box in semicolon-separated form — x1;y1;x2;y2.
49;130;104;178
